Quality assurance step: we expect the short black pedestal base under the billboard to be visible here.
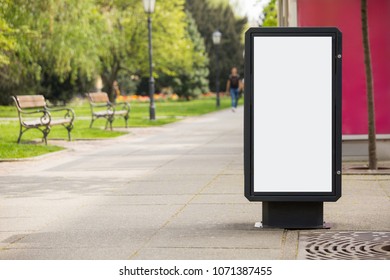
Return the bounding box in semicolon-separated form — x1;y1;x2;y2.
262;201;330;229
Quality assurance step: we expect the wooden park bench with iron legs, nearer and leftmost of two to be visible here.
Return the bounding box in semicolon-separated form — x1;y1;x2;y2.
12;95;74;145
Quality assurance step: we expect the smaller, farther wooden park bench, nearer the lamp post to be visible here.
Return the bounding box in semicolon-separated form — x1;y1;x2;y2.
88;92;130;130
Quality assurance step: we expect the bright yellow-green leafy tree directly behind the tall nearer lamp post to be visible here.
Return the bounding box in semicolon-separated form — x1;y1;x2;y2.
99;0;193;100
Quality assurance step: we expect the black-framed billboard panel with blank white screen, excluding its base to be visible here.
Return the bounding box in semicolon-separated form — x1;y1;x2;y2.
244;28;342;201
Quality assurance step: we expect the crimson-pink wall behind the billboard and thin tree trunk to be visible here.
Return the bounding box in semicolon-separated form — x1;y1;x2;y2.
297;0;390;134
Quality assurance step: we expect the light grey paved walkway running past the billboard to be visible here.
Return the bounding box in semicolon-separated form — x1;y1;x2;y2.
0;108;390;259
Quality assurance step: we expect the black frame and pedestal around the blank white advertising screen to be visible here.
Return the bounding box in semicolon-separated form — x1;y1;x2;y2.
244;27;342;227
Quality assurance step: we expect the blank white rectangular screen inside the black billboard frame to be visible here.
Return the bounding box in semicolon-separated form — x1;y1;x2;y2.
253;36;332;192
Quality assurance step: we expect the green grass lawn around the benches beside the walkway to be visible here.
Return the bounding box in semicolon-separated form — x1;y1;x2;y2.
0;98;230;159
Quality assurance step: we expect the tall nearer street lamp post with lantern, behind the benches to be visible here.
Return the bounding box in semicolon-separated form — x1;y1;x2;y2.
142;0;156;120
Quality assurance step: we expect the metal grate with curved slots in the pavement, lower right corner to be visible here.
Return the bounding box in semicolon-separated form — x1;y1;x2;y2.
298;231;390;260
